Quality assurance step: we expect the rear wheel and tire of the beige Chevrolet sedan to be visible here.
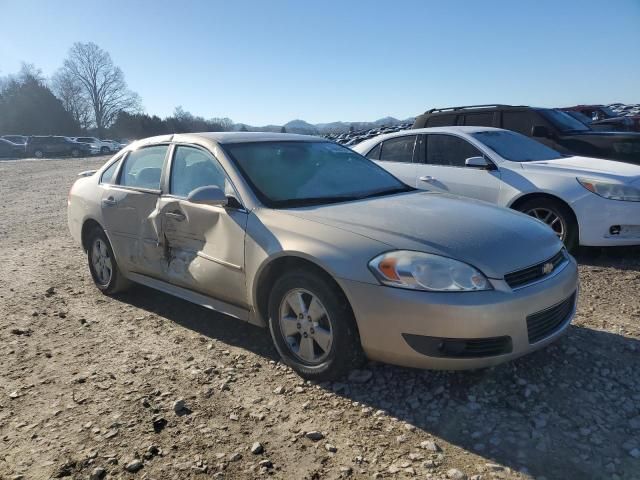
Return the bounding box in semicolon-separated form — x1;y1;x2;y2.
87;228;131;295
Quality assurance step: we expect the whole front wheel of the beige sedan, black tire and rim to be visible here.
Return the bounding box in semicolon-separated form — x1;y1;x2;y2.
269;270;364;381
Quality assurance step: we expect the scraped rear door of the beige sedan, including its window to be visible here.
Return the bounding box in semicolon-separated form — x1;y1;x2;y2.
101;145;169;276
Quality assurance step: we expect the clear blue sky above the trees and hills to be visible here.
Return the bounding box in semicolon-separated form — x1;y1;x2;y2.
0;0;640;125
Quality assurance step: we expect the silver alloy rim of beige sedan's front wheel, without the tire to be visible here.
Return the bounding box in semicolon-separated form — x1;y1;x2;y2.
279;288;333;365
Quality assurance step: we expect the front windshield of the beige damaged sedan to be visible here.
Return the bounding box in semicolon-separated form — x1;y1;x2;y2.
223;141;415;208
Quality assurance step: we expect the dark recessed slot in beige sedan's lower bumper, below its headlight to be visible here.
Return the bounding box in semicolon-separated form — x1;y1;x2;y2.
402;333;513;358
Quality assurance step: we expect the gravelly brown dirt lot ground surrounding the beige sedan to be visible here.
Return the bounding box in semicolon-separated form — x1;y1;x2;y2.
0;158;640;479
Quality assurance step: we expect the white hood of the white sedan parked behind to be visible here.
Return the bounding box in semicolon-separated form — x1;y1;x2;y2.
521;156;640;183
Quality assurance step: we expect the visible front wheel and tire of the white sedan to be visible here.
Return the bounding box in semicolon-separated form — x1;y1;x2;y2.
517;198;579;251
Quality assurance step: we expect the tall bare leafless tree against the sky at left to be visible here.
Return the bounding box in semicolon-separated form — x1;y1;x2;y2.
62;42;140;136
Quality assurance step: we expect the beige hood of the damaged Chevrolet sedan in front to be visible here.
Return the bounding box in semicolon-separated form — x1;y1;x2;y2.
281;192;562;278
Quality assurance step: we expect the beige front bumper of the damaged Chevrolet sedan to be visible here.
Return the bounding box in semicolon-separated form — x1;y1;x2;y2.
340;258;578;370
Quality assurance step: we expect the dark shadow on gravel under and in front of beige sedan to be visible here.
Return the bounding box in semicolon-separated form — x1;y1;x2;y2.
112;286;640;480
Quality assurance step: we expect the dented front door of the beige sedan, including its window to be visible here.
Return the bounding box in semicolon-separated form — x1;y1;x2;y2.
158;145;248;307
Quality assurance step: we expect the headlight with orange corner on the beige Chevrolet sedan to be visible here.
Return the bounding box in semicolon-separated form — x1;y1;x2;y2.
369;250;492;292
